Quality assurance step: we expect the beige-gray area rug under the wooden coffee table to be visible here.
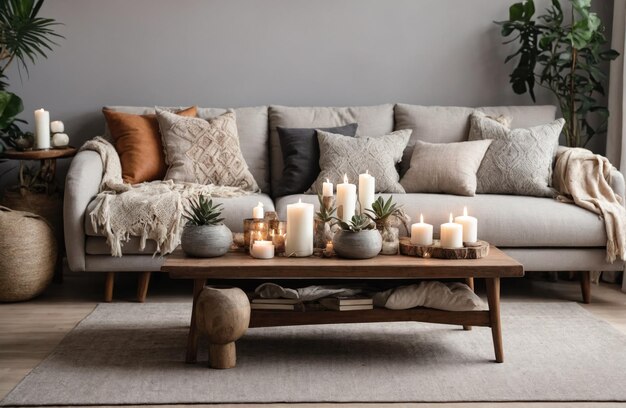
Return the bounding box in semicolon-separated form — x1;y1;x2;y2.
2;302;626;405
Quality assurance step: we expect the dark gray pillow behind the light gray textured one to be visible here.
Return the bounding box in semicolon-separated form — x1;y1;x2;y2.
272;123;358;197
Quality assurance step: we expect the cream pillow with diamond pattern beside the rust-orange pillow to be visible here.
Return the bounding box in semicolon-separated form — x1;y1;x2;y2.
156;108;259;192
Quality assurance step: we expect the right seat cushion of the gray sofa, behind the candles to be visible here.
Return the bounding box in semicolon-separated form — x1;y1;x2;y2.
276;194;606;248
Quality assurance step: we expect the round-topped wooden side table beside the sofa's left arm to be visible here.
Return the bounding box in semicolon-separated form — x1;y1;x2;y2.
0;146;77;283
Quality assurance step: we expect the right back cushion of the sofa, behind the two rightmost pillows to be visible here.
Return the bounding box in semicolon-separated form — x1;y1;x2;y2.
394;103;556;176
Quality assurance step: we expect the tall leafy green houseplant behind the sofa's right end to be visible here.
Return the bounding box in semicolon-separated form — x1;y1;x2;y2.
496;0;619;147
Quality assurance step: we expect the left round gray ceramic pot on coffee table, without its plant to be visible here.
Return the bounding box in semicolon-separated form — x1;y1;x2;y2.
180;224;233;258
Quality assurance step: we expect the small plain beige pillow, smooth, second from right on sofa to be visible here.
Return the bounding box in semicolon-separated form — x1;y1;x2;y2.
400;140;491;196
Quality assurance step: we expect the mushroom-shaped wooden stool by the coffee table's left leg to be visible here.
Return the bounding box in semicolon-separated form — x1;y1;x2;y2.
196;286;250;368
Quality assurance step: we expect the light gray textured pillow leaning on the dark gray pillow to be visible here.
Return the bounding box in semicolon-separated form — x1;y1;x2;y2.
310;129;411;194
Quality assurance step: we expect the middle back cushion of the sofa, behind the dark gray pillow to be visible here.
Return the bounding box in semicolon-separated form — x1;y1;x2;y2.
268;104;393;195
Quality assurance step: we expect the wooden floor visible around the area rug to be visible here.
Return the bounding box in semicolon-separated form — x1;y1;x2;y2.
0;273;626;408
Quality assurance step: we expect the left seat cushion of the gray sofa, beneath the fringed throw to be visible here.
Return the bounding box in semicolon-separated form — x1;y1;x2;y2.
85;194;274;237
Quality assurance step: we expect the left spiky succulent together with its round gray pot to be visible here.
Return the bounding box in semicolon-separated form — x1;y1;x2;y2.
181;196;233;258
